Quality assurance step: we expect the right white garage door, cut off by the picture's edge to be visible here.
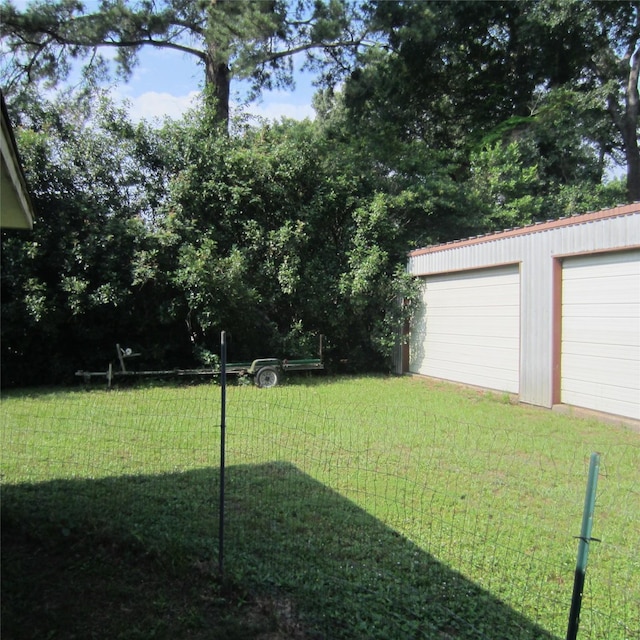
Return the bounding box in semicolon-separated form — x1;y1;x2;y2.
560;251;640;420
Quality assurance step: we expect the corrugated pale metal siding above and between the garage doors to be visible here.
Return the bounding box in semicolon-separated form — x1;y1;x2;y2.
408;210;640;407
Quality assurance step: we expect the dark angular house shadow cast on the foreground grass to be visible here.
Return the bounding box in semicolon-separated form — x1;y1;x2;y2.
2;463;552;640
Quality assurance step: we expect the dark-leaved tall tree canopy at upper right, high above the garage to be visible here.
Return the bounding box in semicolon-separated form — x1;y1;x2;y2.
345;0;640;208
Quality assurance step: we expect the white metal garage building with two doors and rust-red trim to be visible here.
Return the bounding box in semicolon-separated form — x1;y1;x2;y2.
403;204;640;420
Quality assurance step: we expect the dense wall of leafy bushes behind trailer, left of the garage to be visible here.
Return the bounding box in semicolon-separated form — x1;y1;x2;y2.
2;87;415;384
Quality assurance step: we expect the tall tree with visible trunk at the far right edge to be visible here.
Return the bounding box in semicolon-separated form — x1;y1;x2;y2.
528;0;640;202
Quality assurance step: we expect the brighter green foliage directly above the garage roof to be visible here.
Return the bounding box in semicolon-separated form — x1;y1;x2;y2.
467;89;624;231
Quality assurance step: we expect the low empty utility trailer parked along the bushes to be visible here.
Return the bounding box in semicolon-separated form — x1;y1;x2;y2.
75;341;324;389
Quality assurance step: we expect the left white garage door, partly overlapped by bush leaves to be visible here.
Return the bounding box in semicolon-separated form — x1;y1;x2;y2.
409;265;520;393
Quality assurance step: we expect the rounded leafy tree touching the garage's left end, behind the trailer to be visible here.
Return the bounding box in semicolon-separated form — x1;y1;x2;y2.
154;103;420;368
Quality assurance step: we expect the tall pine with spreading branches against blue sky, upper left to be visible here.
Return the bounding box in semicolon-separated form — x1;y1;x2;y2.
0;0;365;126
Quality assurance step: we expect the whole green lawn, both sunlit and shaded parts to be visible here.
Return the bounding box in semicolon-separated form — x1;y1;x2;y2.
1;377;640;640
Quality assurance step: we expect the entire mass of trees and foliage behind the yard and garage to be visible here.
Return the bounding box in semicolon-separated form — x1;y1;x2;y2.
0;0;640;384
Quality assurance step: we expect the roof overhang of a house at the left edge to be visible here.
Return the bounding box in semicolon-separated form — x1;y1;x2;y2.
0;94;34;229
